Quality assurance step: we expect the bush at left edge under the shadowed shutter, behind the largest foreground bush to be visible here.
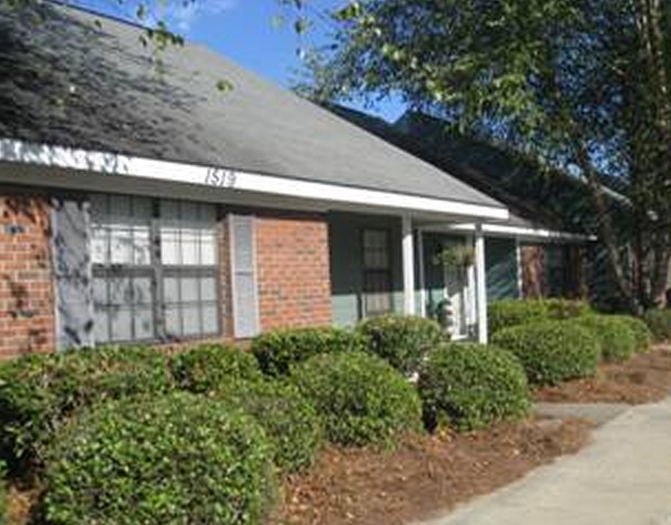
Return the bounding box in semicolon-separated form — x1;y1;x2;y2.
0;347;173;473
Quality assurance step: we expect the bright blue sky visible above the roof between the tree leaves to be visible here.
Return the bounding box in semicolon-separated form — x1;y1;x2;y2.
75;0;404;121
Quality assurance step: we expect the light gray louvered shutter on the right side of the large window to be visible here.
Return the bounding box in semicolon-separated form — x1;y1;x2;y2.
228;215;259;338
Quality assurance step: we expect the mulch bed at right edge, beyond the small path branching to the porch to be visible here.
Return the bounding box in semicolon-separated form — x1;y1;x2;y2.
534;346;671;405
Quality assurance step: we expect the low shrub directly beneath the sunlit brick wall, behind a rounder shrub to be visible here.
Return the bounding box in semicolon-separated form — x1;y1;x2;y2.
252;327;364;377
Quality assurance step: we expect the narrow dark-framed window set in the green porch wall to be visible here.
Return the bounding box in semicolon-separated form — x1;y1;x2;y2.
363;226;393;316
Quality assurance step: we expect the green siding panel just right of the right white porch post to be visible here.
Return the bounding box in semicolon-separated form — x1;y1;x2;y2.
485;237;519;301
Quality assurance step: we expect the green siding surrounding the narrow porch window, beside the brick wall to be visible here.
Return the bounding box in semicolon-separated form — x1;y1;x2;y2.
328;213;403;327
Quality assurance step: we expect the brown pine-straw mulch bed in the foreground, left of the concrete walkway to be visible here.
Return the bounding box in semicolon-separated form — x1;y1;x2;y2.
271;419;589;525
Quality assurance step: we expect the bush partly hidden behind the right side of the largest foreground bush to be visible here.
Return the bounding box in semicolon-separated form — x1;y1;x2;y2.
215;381;324;472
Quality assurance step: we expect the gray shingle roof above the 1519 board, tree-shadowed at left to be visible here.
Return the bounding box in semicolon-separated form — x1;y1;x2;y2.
0;3;504;208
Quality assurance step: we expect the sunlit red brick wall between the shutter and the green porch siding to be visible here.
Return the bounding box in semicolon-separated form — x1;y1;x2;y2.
256;214;331;331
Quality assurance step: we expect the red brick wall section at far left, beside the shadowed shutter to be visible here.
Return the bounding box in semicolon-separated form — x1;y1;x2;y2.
0;194;55;359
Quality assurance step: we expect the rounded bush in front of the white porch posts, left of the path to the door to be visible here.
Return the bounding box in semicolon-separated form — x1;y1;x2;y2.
418;344;531;431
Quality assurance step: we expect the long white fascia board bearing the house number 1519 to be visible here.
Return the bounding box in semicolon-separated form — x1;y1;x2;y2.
0;139;508;220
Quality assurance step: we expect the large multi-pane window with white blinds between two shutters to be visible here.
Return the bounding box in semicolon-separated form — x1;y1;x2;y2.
91;195;220;343
